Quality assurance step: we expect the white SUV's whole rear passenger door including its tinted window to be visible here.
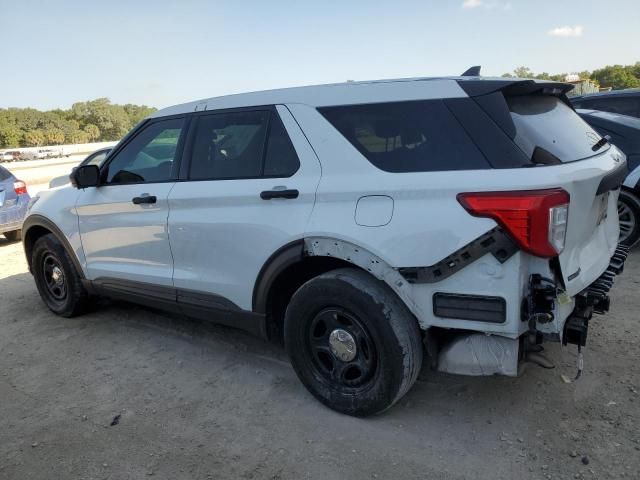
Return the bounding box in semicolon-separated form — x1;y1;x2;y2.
169;106;320;310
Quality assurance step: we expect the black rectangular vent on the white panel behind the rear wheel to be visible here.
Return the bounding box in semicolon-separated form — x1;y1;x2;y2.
433;292;507;323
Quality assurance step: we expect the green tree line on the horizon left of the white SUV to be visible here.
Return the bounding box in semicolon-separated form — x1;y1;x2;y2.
0;98;156;148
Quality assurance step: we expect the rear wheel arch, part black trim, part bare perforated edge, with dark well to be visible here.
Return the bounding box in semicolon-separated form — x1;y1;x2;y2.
252;237;419;339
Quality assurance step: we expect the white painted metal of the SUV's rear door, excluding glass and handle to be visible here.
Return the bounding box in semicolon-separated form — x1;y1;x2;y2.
169;106;321;310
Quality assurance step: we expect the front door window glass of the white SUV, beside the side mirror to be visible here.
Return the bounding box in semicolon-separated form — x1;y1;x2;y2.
106;118;184;184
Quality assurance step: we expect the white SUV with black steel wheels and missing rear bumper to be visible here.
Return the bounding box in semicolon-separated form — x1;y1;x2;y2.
23;77;627;416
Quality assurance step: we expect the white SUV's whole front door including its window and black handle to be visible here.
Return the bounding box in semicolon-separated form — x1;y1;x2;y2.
76;118;185;286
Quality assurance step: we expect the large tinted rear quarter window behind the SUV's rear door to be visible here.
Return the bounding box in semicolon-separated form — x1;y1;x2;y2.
319;100;490;172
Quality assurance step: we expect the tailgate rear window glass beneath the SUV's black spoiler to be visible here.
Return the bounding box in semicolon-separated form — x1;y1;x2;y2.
507;95;609;164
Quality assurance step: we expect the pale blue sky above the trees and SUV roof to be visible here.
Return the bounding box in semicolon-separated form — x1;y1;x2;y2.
0;0;640;109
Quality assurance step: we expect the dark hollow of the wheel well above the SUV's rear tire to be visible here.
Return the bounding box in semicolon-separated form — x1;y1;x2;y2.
265;256;360;342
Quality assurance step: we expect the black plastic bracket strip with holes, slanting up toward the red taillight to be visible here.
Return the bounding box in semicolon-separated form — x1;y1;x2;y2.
399;227;519;283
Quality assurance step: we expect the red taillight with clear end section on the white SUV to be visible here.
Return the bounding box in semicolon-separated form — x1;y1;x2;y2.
458;188;569;257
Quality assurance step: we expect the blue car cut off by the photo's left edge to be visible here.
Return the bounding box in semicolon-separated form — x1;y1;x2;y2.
0;166;31;242
